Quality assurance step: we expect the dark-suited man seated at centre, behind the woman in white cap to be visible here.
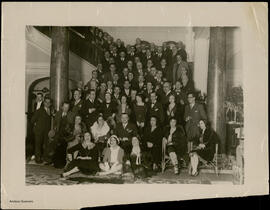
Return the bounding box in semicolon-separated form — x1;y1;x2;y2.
115;113;138;156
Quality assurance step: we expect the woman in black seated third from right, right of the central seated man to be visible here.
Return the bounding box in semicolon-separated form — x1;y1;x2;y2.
143;116;163;171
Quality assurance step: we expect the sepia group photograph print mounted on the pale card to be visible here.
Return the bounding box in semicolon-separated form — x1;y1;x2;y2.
25;26;244;185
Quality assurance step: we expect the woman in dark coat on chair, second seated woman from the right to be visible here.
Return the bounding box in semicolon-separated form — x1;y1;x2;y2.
163;117;187;174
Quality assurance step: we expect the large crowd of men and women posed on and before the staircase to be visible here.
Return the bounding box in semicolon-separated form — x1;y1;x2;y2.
31;35;218;180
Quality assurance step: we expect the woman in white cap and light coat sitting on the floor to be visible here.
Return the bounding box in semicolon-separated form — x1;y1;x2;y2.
99;135;124;175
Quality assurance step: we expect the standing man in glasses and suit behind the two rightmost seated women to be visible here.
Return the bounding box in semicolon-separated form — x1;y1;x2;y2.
184;93;207;151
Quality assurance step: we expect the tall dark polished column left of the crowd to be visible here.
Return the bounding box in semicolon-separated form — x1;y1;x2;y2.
50;26;69;111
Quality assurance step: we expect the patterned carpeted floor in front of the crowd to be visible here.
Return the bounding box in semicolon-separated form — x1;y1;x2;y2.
26;164;233;185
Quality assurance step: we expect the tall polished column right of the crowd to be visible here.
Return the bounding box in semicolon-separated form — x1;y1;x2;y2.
207;27;226;154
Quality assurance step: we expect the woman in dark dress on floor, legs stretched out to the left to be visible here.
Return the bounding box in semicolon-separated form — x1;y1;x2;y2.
61;132;99;177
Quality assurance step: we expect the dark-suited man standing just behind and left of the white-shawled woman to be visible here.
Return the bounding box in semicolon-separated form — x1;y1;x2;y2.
82;89;99;129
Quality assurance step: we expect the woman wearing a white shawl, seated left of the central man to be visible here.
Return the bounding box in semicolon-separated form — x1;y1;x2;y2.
90;114;110;157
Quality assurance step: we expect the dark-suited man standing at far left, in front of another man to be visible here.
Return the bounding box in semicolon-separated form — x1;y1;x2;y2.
31;98;51;163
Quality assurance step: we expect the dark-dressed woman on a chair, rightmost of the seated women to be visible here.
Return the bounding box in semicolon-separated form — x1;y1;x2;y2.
189;120;218;176
